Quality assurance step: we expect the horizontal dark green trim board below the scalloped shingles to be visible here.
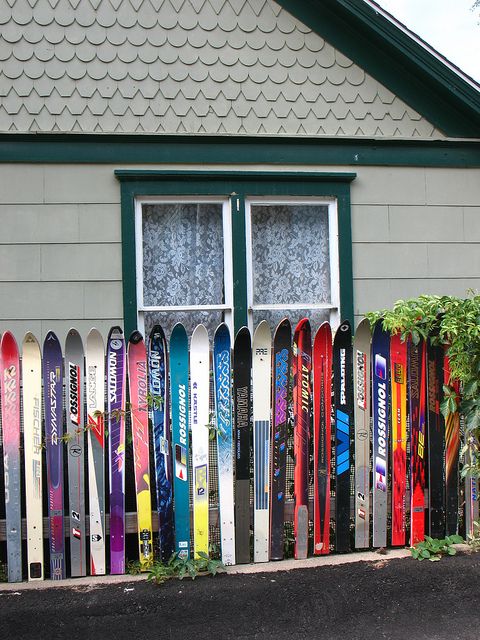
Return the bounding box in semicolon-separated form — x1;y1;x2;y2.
0;134;480;168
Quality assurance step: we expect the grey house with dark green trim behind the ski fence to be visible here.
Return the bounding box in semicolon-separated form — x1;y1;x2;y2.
0;0;480;340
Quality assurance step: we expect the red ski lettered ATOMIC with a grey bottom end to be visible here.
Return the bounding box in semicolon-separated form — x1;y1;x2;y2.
292;318;312;560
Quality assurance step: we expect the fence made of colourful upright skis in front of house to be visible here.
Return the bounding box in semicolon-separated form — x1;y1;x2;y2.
0;319;478;582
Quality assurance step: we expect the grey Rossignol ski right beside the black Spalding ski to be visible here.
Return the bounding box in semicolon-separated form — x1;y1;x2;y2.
353;318;372;549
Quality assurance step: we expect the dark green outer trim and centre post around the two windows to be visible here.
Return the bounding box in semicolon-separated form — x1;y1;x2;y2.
115;170;356;335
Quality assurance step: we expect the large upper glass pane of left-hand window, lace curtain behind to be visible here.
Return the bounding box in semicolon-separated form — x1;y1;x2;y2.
142;203;224;306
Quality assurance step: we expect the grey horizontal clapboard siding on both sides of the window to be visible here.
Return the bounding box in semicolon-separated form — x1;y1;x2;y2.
0;165;480;338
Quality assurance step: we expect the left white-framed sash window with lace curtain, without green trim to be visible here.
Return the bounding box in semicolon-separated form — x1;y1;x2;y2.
135;198;233;335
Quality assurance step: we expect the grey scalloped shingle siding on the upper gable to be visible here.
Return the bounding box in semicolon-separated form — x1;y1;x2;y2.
0;0;443;138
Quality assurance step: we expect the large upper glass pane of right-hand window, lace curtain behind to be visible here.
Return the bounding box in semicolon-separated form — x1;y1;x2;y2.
251;204;331;305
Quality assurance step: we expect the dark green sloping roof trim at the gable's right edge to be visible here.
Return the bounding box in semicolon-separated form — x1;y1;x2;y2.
277;0;480;138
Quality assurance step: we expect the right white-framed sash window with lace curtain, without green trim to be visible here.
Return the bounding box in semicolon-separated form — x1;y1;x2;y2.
246;198;340;327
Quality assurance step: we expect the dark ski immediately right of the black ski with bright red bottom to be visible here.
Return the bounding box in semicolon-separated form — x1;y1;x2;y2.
426;338;445;538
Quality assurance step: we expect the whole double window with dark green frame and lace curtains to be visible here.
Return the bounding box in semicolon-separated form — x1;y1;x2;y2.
115;170;355;334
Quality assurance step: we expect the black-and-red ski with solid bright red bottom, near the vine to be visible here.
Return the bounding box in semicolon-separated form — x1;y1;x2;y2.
408;338;426;547
